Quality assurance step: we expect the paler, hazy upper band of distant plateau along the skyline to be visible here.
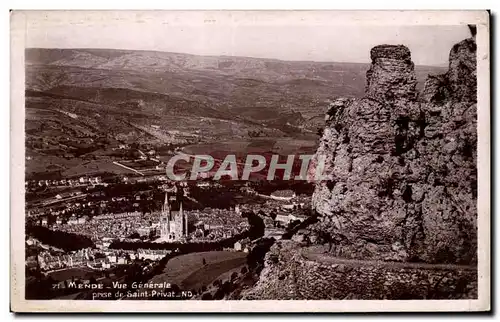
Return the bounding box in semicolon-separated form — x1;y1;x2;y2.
26;49;443;118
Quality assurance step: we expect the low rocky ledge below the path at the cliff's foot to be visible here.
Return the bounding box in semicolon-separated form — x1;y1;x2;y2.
243;240;477;300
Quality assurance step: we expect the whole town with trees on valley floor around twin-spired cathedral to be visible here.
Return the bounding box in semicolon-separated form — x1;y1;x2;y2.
26;162;310;297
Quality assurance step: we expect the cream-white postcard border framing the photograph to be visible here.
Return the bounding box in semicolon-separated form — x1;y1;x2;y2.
10;10;491;312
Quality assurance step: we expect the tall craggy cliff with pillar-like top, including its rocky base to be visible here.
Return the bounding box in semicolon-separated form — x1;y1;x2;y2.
244;38;477;299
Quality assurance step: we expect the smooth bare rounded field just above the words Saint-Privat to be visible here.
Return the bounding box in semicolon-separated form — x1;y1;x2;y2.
150;251;247;289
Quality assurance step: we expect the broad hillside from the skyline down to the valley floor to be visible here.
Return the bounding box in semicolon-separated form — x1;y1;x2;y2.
25;48;443;177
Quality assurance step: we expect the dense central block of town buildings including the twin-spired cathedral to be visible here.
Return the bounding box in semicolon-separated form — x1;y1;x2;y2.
49;191;248;244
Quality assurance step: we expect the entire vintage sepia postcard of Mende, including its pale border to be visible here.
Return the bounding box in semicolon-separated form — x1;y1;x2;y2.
10;10;490;312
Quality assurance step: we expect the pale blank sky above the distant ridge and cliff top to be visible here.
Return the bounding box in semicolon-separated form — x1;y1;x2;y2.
21;14;470;66
